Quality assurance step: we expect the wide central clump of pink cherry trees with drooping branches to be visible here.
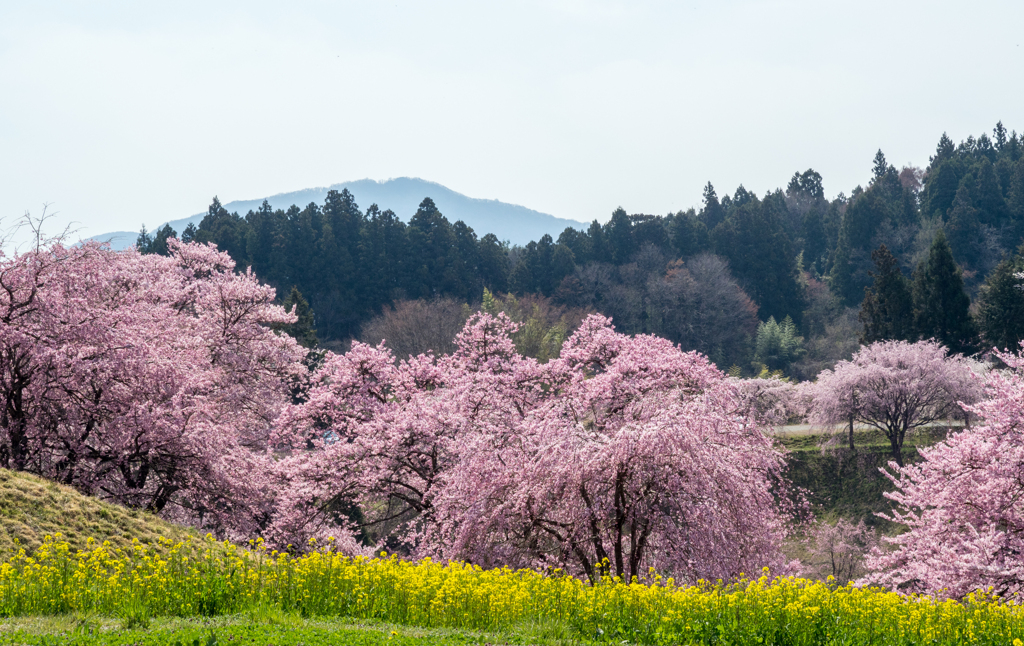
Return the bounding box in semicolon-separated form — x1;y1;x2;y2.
275;313;788;579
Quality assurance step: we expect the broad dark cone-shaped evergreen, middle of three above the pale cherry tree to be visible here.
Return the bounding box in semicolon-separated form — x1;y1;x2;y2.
913;229;976;353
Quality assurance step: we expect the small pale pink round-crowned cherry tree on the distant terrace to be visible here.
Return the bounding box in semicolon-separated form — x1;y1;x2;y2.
808;341;982;466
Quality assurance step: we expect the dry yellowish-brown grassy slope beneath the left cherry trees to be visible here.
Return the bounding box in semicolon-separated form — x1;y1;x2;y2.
0;469;191;559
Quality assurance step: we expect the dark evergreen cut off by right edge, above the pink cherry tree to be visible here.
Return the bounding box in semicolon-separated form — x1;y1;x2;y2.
978;247;1024;350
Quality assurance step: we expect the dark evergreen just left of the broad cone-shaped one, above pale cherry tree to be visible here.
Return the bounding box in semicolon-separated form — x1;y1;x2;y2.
859;245;913;344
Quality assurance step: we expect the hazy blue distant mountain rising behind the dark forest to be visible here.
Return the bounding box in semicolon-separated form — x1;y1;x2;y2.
91;177;587;249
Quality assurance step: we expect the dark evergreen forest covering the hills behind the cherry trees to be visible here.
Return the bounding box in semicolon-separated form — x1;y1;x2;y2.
138;123;1024;379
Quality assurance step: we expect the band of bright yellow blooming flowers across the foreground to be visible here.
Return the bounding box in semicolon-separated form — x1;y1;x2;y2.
0;535;1024;646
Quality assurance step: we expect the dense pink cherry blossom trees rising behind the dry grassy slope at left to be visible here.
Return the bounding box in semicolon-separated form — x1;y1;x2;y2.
0;231;302;535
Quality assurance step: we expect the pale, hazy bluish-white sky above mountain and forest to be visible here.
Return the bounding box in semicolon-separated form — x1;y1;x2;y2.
0;0;1024;241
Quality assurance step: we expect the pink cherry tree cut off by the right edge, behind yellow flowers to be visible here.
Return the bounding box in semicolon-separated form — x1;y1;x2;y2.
866;346;1024;597
